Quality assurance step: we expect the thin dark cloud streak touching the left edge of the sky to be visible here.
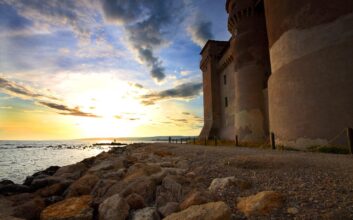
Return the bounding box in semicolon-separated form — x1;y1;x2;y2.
0;77;59;100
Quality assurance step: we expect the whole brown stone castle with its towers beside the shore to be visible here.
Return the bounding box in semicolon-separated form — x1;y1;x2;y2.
200;0;353;150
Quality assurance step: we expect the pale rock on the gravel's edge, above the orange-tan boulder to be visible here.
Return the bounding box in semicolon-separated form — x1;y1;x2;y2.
208;176;251;193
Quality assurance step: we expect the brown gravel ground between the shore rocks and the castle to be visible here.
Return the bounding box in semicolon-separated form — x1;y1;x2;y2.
136;144;353;219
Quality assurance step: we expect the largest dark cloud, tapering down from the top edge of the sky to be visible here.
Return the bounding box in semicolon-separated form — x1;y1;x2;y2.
103;0;184;81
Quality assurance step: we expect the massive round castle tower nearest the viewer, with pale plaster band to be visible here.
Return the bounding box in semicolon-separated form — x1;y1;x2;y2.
265;0;353;147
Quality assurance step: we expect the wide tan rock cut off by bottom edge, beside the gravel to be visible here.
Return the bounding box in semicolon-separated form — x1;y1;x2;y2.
164;202;231;220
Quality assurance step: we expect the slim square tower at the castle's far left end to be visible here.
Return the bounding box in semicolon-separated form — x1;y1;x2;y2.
199;40;229;139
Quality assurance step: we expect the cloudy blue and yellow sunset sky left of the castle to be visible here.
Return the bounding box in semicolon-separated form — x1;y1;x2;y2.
0;0;230;140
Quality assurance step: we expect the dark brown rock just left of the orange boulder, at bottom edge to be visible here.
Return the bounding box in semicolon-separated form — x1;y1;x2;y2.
13;197;45;220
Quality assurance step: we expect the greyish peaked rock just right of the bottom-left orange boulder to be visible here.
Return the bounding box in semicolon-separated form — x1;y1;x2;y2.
99;194;130;220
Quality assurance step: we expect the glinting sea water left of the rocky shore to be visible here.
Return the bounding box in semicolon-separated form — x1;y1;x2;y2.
0;138;169;184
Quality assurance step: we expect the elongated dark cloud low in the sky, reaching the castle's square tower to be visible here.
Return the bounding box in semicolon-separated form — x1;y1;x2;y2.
142;83;202;105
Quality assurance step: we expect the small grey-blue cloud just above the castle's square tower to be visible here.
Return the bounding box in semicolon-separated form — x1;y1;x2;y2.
187;21;213;47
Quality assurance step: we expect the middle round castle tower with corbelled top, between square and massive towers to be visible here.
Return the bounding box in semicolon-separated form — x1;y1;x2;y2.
226;0;271;142
